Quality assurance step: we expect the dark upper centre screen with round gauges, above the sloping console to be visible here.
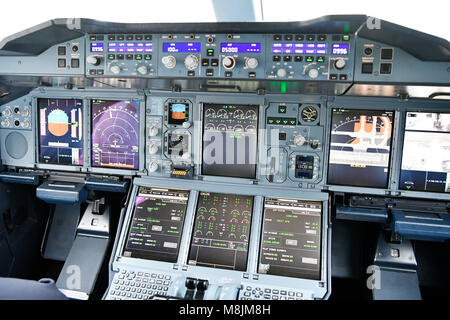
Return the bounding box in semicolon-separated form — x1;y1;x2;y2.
202;104;258;179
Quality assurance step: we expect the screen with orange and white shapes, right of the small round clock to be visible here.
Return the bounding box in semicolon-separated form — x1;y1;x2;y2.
328;109;394;188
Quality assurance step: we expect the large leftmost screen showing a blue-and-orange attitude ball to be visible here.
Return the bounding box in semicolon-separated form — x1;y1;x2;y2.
37;99;84;166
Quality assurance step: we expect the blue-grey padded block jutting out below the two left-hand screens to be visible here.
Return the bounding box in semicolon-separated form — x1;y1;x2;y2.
36;181;87;204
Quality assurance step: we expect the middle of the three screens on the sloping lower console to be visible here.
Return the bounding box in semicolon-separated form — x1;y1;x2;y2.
188;192;253;271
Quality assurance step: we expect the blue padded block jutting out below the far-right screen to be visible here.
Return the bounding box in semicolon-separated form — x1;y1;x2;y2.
391;210;450;241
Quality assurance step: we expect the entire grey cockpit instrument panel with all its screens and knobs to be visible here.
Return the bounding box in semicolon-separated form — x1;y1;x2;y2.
0;16;450;300
